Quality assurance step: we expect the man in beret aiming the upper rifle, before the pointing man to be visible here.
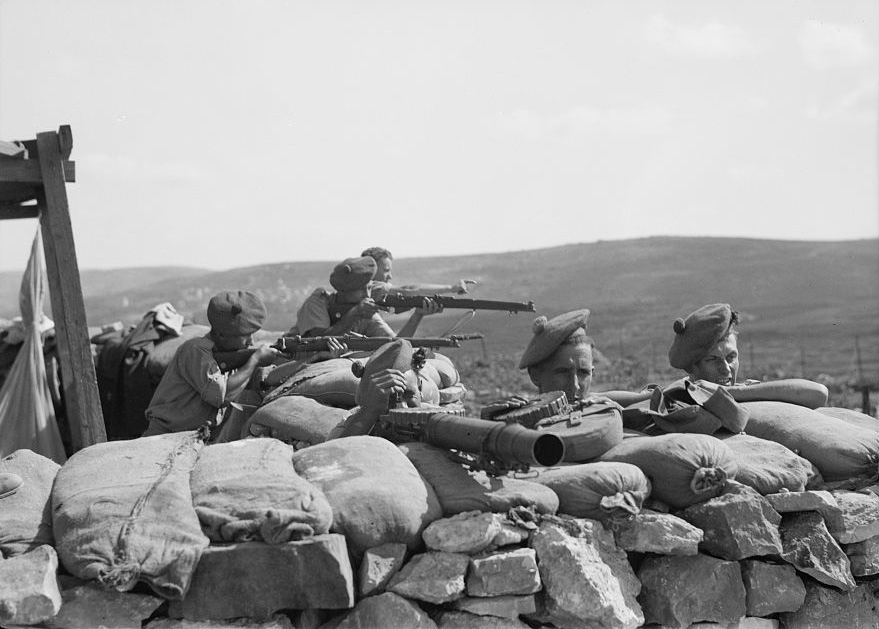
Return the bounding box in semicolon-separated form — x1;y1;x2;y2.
289;256;442;337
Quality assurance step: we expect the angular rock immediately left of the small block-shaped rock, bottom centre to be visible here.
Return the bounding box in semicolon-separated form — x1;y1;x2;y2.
385;551;470;605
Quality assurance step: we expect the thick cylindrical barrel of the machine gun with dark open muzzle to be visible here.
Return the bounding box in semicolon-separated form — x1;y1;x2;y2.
390;409;565;466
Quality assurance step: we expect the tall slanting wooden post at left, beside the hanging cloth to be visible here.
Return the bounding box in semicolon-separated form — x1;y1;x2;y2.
37;129;107;450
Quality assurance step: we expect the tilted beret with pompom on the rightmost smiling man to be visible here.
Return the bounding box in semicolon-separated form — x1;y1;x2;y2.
668;304;739;369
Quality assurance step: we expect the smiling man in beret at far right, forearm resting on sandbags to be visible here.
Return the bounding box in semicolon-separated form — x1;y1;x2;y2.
668;304;828;408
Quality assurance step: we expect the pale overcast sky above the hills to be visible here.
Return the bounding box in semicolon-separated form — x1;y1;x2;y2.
0;0;879;270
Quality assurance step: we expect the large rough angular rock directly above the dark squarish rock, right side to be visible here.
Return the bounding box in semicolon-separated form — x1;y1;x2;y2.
678;483;781;561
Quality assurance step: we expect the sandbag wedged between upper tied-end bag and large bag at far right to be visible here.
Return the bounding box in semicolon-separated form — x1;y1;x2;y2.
715;432;822;496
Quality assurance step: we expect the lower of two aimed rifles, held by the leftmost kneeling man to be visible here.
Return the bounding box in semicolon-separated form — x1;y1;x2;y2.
214;334;482;371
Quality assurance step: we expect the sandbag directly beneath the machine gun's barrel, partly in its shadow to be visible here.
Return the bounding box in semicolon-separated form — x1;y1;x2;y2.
399;442;559;517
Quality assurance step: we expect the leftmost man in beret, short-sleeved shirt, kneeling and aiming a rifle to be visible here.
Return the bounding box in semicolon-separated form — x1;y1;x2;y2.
143;291;278;437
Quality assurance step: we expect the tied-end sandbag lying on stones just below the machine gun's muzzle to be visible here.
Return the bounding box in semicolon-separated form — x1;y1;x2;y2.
534;462;650;524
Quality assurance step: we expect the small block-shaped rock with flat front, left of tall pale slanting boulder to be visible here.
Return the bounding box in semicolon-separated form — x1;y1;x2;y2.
465;548;541;596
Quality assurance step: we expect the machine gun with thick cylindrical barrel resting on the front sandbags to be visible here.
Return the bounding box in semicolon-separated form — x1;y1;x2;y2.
377;408;565;476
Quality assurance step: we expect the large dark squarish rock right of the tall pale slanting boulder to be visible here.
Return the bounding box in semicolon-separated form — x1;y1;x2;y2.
638;554;746;629
